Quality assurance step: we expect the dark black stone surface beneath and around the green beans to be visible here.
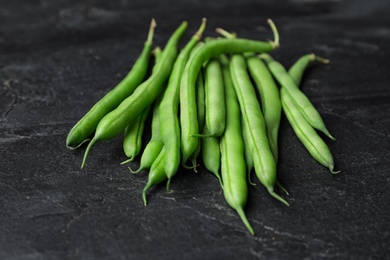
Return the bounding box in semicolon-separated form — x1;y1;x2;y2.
0;0;390;259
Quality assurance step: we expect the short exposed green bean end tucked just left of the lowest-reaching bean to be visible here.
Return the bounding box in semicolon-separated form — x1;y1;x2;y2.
201;126;223;187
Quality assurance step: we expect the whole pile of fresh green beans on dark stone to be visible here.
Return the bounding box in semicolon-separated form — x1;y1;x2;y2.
66;18;338;235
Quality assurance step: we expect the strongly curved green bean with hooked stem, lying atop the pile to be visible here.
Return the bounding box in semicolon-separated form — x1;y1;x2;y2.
180;20;279;165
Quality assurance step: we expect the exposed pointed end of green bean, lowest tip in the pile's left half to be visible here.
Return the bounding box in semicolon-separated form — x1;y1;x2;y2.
142;146;167;205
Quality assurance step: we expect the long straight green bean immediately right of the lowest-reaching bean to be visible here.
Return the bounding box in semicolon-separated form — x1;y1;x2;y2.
230;54;288;205
